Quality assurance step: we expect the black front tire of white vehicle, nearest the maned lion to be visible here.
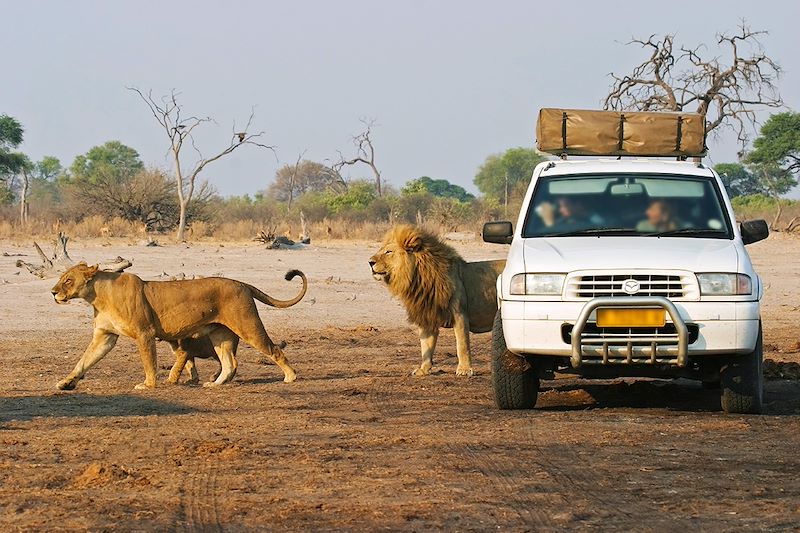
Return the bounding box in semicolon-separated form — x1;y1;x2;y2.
492;309;539;409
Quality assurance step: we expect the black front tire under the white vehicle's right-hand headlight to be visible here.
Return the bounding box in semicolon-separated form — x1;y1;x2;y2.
720;323;764;414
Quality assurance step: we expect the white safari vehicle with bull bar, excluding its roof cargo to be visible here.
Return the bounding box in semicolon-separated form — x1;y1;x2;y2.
483;109;768;413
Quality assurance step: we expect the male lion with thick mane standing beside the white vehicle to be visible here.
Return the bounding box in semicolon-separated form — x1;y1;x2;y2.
369;226;505;376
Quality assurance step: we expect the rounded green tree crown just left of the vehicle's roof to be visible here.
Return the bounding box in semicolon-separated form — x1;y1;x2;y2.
474;147;545;201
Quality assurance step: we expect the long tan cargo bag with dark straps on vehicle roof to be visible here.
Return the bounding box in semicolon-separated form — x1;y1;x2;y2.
536;108;706;157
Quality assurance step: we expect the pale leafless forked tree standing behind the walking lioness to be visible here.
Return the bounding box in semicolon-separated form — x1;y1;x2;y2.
128;87;274;242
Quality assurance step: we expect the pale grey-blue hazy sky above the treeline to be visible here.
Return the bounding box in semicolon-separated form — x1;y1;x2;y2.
0;0;800;195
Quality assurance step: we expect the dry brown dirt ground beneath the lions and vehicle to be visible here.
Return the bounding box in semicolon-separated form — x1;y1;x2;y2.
0;235;800;531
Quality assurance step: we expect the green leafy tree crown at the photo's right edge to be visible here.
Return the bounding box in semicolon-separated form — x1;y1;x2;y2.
747;111;800;174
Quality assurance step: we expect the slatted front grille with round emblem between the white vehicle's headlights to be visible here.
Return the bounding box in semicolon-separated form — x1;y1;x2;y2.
565;272;699;300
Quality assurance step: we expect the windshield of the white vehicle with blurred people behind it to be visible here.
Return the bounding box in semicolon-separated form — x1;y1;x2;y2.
522;174;733;239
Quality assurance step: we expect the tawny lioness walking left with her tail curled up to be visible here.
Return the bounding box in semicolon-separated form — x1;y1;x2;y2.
51;263;308;389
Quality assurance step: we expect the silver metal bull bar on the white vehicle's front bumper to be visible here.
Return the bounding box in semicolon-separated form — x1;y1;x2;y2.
570;296;689;368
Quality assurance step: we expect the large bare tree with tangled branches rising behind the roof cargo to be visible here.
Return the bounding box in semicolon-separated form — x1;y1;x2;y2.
604;22;783;149
